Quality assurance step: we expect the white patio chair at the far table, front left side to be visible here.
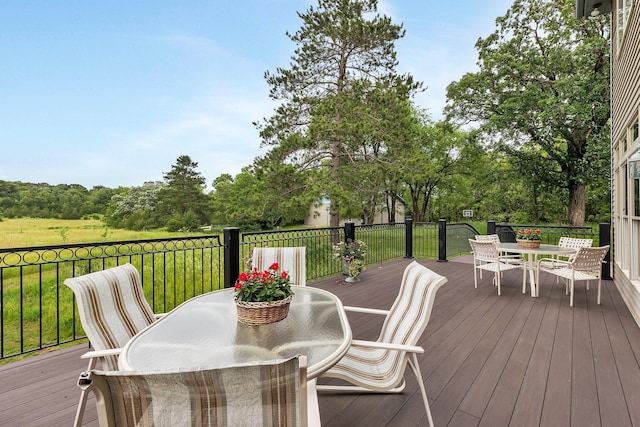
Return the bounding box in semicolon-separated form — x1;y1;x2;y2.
469;239;527;295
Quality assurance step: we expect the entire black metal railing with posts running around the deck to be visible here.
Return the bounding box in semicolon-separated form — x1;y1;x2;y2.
0;219;610;360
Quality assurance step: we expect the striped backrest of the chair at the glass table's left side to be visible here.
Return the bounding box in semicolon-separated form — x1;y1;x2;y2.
64;264;155;370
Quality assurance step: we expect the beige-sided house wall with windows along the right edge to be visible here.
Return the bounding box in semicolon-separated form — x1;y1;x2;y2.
611;0;640;325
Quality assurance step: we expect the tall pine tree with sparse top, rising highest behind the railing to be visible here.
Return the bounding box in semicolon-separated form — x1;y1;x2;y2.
256;0;421;226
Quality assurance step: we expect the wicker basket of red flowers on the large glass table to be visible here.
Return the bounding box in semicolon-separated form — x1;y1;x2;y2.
234;263;293;325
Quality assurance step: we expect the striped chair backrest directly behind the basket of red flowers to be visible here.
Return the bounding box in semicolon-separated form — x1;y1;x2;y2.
251;246;307;286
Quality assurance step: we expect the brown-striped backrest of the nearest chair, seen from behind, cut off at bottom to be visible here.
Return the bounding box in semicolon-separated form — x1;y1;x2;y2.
78;356;307;427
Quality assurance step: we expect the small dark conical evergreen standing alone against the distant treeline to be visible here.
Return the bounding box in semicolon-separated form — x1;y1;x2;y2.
159;155;209;224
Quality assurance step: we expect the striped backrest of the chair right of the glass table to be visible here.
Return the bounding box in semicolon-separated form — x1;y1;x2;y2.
378;261;447;383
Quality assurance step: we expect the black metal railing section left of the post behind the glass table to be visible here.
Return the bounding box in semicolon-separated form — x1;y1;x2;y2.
0;235;223;359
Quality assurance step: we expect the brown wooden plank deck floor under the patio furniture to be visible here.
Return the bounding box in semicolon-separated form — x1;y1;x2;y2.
0;257;640;427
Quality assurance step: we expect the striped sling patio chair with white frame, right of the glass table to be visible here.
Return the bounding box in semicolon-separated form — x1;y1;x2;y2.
317;261;447;426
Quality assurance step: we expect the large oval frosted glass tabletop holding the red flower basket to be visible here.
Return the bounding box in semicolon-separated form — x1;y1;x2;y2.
118;286;351;379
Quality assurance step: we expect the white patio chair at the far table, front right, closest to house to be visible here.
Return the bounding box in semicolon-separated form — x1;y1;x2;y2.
536;245;609;307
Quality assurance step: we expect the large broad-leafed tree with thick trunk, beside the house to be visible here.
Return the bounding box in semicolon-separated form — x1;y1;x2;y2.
446;0;609;225
